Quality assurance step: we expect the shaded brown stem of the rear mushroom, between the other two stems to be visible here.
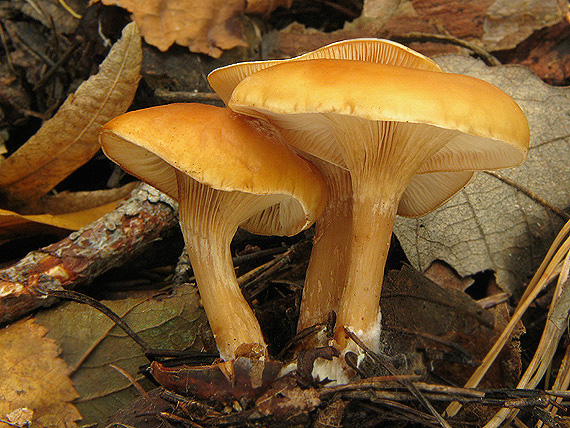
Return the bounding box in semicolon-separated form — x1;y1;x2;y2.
297;164;352;334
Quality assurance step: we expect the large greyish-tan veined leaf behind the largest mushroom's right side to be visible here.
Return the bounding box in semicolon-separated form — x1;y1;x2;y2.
395;55;570;293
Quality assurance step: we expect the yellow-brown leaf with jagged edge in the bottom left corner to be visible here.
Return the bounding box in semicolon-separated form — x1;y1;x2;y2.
0;319;81;428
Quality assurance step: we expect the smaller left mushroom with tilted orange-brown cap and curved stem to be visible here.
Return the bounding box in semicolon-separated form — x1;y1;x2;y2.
100;104;327;361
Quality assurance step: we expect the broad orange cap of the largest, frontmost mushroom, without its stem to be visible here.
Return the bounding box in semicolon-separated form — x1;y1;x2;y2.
228;59;529;216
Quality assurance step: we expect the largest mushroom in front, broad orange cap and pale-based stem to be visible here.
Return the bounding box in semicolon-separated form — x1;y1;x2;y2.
223;51;529;351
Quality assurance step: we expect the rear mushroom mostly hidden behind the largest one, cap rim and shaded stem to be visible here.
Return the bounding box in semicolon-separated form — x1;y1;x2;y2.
208;38;441;331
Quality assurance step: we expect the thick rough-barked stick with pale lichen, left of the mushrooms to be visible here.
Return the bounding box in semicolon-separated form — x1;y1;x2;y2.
0;185;178;323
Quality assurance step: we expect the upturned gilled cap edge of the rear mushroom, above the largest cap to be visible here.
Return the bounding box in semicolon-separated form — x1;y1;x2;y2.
208;38;442;105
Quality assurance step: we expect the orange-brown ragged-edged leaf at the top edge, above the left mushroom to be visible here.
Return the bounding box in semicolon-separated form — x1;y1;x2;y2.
97;0;247;58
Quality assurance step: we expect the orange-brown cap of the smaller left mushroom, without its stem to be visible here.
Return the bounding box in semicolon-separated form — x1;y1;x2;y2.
99;103;327;235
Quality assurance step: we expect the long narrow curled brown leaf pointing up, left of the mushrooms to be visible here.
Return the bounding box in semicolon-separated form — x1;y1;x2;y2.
0;24;142;208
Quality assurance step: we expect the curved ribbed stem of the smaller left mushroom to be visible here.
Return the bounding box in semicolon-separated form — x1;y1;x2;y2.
177;172;272;361
